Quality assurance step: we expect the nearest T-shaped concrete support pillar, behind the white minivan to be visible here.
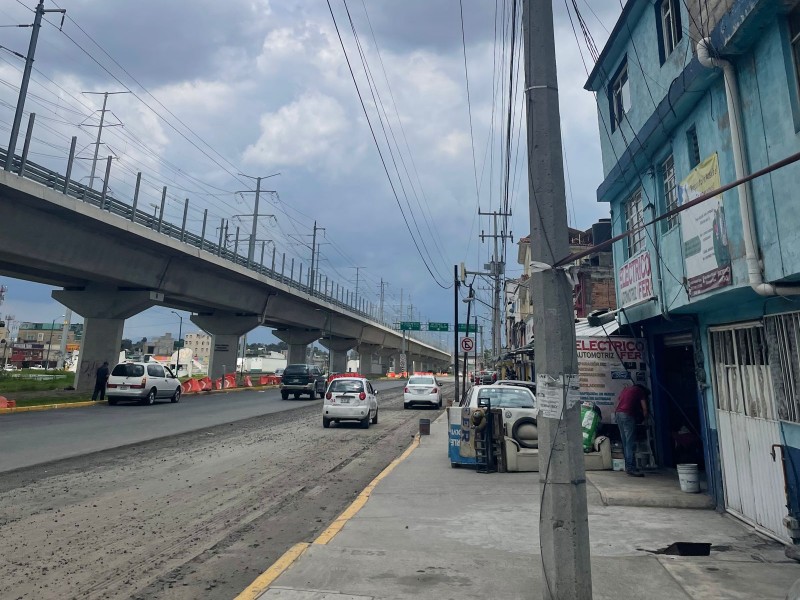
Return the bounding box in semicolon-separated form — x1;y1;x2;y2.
51;285;164;392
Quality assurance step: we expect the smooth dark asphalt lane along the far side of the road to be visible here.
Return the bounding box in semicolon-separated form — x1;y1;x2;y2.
0;381;410;473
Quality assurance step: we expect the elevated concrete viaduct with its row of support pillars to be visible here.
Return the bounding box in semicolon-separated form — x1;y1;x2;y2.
0;171;450;390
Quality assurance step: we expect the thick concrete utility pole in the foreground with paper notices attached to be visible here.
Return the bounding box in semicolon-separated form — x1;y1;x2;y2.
523;0;592;600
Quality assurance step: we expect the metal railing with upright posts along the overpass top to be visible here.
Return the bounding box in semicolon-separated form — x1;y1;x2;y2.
0;144;448;352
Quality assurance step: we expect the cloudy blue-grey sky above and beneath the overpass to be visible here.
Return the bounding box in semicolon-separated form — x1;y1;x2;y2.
0;0;621;350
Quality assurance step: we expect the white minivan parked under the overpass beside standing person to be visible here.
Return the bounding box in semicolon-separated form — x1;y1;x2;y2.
106;362;181;404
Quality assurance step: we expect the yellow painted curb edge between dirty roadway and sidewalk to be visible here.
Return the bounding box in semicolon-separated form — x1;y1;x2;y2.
234;434;419;600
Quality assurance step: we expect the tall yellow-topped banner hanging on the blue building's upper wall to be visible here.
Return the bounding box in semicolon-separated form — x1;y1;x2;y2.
678;154;731;297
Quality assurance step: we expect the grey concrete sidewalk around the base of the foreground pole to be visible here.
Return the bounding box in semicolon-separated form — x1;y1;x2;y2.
251;415;800;600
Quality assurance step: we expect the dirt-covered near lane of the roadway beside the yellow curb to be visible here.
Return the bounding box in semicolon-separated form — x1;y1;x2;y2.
0;385;452;600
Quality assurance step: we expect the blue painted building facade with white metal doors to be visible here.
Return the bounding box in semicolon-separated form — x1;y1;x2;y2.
586;0;800;543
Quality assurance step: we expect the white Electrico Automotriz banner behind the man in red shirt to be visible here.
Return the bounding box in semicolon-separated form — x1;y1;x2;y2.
576;337;650;423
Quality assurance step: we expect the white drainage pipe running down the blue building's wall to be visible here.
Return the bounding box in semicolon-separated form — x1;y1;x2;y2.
697;38;800;296
